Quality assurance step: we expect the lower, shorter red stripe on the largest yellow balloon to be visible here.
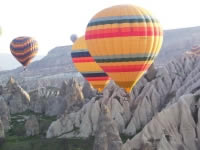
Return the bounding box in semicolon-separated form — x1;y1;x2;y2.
101;65;150;72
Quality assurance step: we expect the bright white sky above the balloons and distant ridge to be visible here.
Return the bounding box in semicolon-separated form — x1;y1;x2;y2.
0;0;200;55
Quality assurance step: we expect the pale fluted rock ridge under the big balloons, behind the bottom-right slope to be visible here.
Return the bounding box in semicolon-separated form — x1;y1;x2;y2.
47;54;200;140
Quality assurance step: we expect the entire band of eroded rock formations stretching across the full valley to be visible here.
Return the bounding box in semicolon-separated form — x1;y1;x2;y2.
0;47;200;150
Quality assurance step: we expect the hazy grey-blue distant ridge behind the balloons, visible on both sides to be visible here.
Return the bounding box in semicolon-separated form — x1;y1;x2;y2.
0;26;200;87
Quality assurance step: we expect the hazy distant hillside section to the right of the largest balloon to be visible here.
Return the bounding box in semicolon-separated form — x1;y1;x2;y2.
156;27;200;64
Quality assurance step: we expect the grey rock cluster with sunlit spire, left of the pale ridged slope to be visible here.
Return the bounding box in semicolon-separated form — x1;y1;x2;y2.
29;79;85;116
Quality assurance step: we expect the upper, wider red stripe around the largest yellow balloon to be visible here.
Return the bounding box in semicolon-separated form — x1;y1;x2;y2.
85;27;162;40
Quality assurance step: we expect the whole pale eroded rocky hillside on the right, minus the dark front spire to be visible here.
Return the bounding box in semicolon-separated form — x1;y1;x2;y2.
47;51;200;150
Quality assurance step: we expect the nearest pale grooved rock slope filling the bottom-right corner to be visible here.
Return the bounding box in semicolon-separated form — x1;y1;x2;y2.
123;94;200;150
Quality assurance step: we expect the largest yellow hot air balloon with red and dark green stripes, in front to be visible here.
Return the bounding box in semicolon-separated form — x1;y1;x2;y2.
85;5;163;92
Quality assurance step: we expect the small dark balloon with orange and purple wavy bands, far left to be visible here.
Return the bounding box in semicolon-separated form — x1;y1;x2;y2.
10;36;38;68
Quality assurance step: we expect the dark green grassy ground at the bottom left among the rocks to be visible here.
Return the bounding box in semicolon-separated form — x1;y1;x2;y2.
0;112;94;150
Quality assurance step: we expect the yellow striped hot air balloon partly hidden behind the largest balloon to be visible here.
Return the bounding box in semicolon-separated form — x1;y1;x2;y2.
71;36;109;92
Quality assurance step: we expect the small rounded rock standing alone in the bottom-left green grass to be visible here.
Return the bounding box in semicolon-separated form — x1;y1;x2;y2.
25;115;39;136
